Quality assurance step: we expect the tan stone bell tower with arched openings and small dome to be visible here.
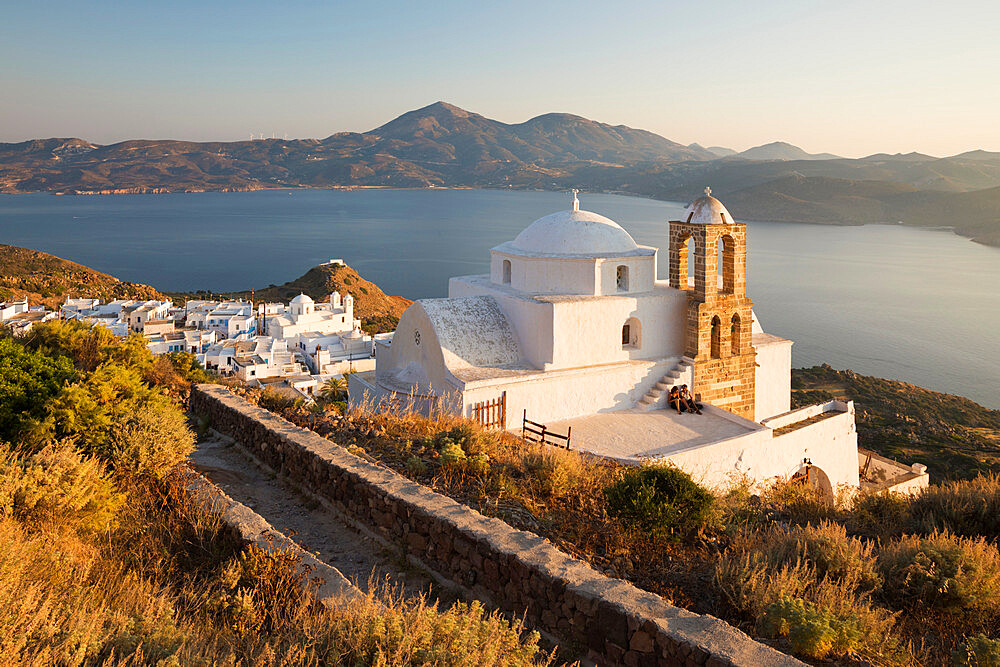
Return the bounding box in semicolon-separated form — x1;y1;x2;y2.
669;188;757;420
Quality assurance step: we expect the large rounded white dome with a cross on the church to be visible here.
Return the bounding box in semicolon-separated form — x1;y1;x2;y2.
511;210;639;255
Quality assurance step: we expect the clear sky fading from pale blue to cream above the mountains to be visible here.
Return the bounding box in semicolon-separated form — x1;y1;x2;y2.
0;0;1000;157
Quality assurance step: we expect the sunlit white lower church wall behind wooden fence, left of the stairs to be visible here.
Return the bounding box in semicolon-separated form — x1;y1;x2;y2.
462;358;679;428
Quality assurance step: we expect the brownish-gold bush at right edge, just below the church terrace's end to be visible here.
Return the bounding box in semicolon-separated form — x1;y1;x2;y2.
910;474;1000;540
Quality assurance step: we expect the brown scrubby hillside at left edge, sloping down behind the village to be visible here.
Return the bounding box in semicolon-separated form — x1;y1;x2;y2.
0;245;161;308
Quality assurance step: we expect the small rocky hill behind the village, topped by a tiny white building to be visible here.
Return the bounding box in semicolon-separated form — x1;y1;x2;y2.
200;264;413;333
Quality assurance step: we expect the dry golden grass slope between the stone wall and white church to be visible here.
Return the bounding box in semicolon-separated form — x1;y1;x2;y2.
250;392;1000;665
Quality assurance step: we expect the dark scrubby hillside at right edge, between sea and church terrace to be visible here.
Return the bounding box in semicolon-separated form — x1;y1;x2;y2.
792;364;1000;482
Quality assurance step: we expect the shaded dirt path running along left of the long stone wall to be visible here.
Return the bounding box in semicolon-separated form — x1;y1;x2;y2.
190;432;455;604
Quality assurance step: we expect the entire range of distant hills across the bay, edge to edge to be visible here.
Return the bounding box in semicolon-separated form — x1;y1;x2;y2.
0;102;1000;245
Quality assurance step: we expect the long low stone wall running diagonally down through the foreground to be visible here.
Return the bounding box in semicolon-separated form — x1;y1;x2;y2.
190;385;802;666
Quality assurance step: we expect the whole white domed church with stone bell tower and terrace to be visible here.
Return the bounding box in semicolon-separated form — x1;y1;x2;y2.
349;188;928;493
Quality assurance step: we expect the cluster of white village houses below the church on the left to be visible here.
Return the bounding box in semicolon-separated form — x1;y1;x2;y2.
0;260;386;400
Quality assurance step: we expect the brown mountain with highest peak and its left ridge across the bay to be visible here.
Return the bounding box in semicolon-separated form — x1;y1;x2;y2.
0;102;715;194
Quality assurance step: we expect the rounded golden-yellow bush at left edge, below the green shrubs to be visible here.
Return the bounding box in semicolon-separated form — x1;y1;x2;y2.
0;444;122;532
